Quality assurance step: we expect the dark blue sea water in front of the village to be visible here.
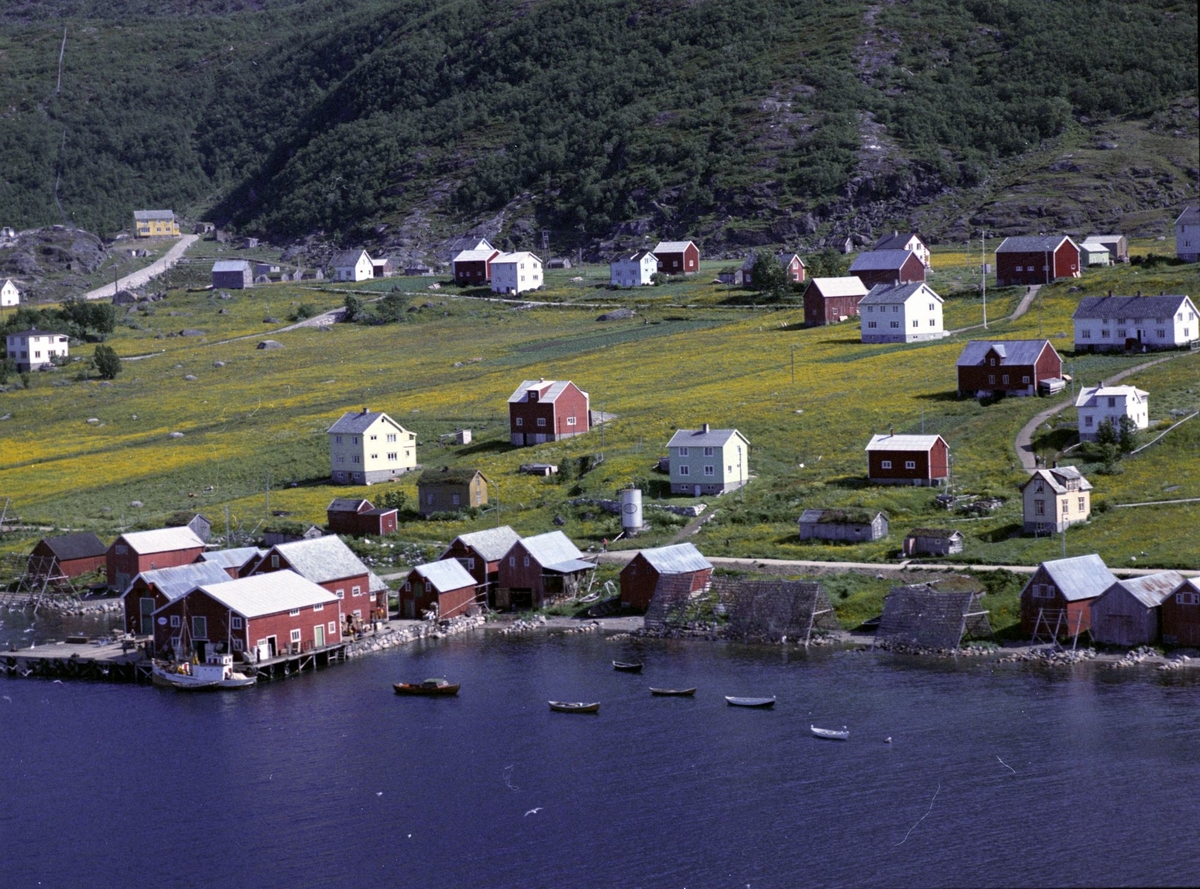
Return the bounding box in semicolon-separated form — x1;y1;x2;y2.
0;623;1200;889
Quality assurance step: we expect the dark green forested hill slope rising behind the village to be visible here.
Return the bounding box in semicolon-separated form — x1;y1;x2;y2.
0;0;1200;251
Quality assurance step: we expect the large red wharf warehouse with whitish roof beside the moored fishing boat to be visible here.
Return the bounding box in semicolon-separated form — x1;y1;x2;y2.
154;571;342;660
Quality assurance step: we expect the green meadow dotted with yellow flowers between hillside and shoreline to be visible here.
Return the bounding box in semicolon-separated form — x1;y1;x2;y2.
0;245;1200;628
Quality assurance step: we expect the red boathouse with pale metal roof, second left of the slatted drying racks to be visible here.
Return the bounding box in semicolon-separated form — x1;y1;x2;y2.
496;531;595;611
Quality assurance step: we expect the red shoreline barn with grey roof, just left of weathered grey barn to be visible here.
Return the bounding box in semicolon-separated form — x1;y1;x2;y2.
1021;553;1117;637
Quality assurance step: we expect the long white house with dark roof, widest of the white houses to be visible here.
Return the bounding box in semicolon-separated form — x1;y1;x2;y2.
1072;294;1200;352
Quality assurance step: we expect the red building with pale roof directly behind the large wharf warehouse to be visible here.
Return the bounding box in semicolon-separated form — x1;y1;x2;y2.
250;535;388;623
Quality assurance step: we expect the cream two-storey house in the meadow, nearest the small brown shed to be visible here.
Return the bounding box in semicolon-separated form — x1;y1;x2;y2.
326;408;416;485
